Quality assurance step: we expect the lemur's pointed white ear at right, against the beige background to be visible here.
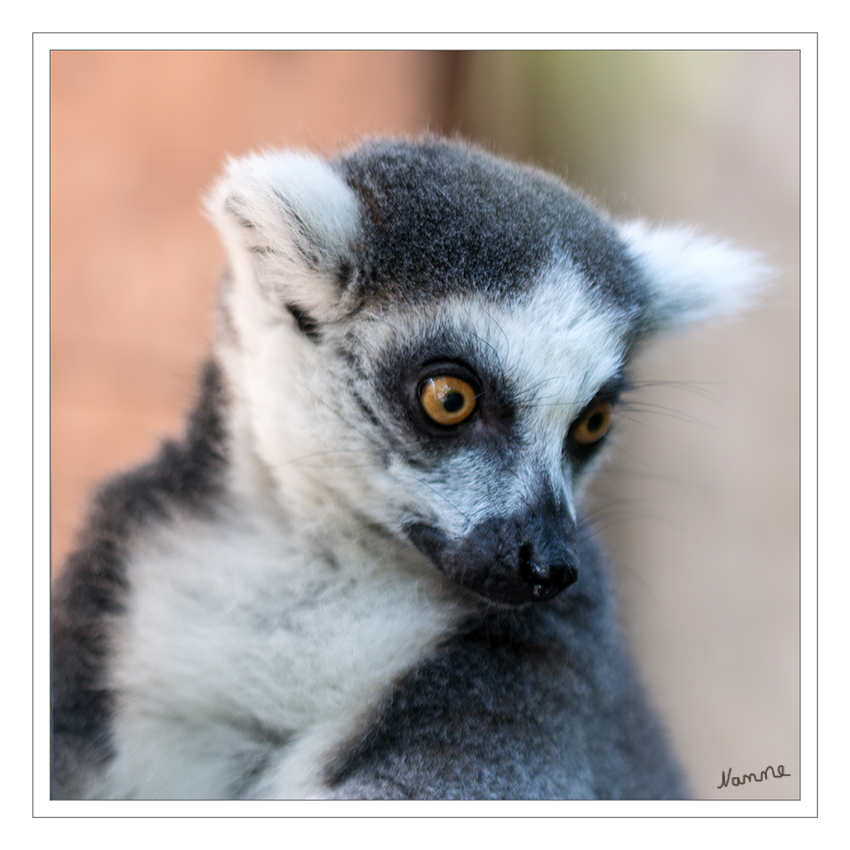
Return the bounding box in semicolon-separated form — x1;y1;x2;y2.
619;221;774;331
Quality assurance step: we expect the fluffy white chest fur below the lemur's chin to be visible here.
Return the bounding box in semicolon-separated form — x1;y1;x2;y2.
95;506;458;799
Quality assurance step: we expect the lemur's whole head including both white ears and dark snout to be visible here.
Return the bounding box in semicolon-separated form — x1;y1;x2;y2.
210;139;765;605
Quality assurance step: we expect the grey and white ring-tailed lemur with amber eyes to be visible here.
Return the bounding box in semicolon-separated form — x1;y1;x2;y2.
53;134;765;799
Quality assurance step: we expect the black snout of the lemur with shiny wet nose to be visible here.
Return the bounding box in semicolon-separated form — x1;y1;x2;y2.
406;503;578;605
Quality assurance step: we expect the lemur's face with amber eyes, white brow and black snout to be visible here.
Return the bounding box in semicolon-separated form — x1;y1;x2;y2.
316;278;629;604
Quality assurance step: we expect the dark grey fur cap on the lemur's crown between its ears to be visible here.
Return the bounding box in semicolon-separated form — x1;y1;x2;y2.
334;140;645;309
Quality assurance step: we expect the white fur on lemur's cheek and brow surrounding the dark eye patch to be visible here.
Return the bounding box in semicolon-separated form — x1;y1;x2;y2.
215;270;628;556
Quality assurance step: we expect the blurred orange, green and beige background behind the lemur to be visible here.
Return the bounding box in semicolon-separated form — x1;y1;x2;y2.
51;51;800;799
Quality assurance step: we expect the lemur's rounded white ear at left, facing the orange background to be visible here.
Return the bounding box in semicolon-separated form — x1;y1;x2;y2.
207;151;360;329
